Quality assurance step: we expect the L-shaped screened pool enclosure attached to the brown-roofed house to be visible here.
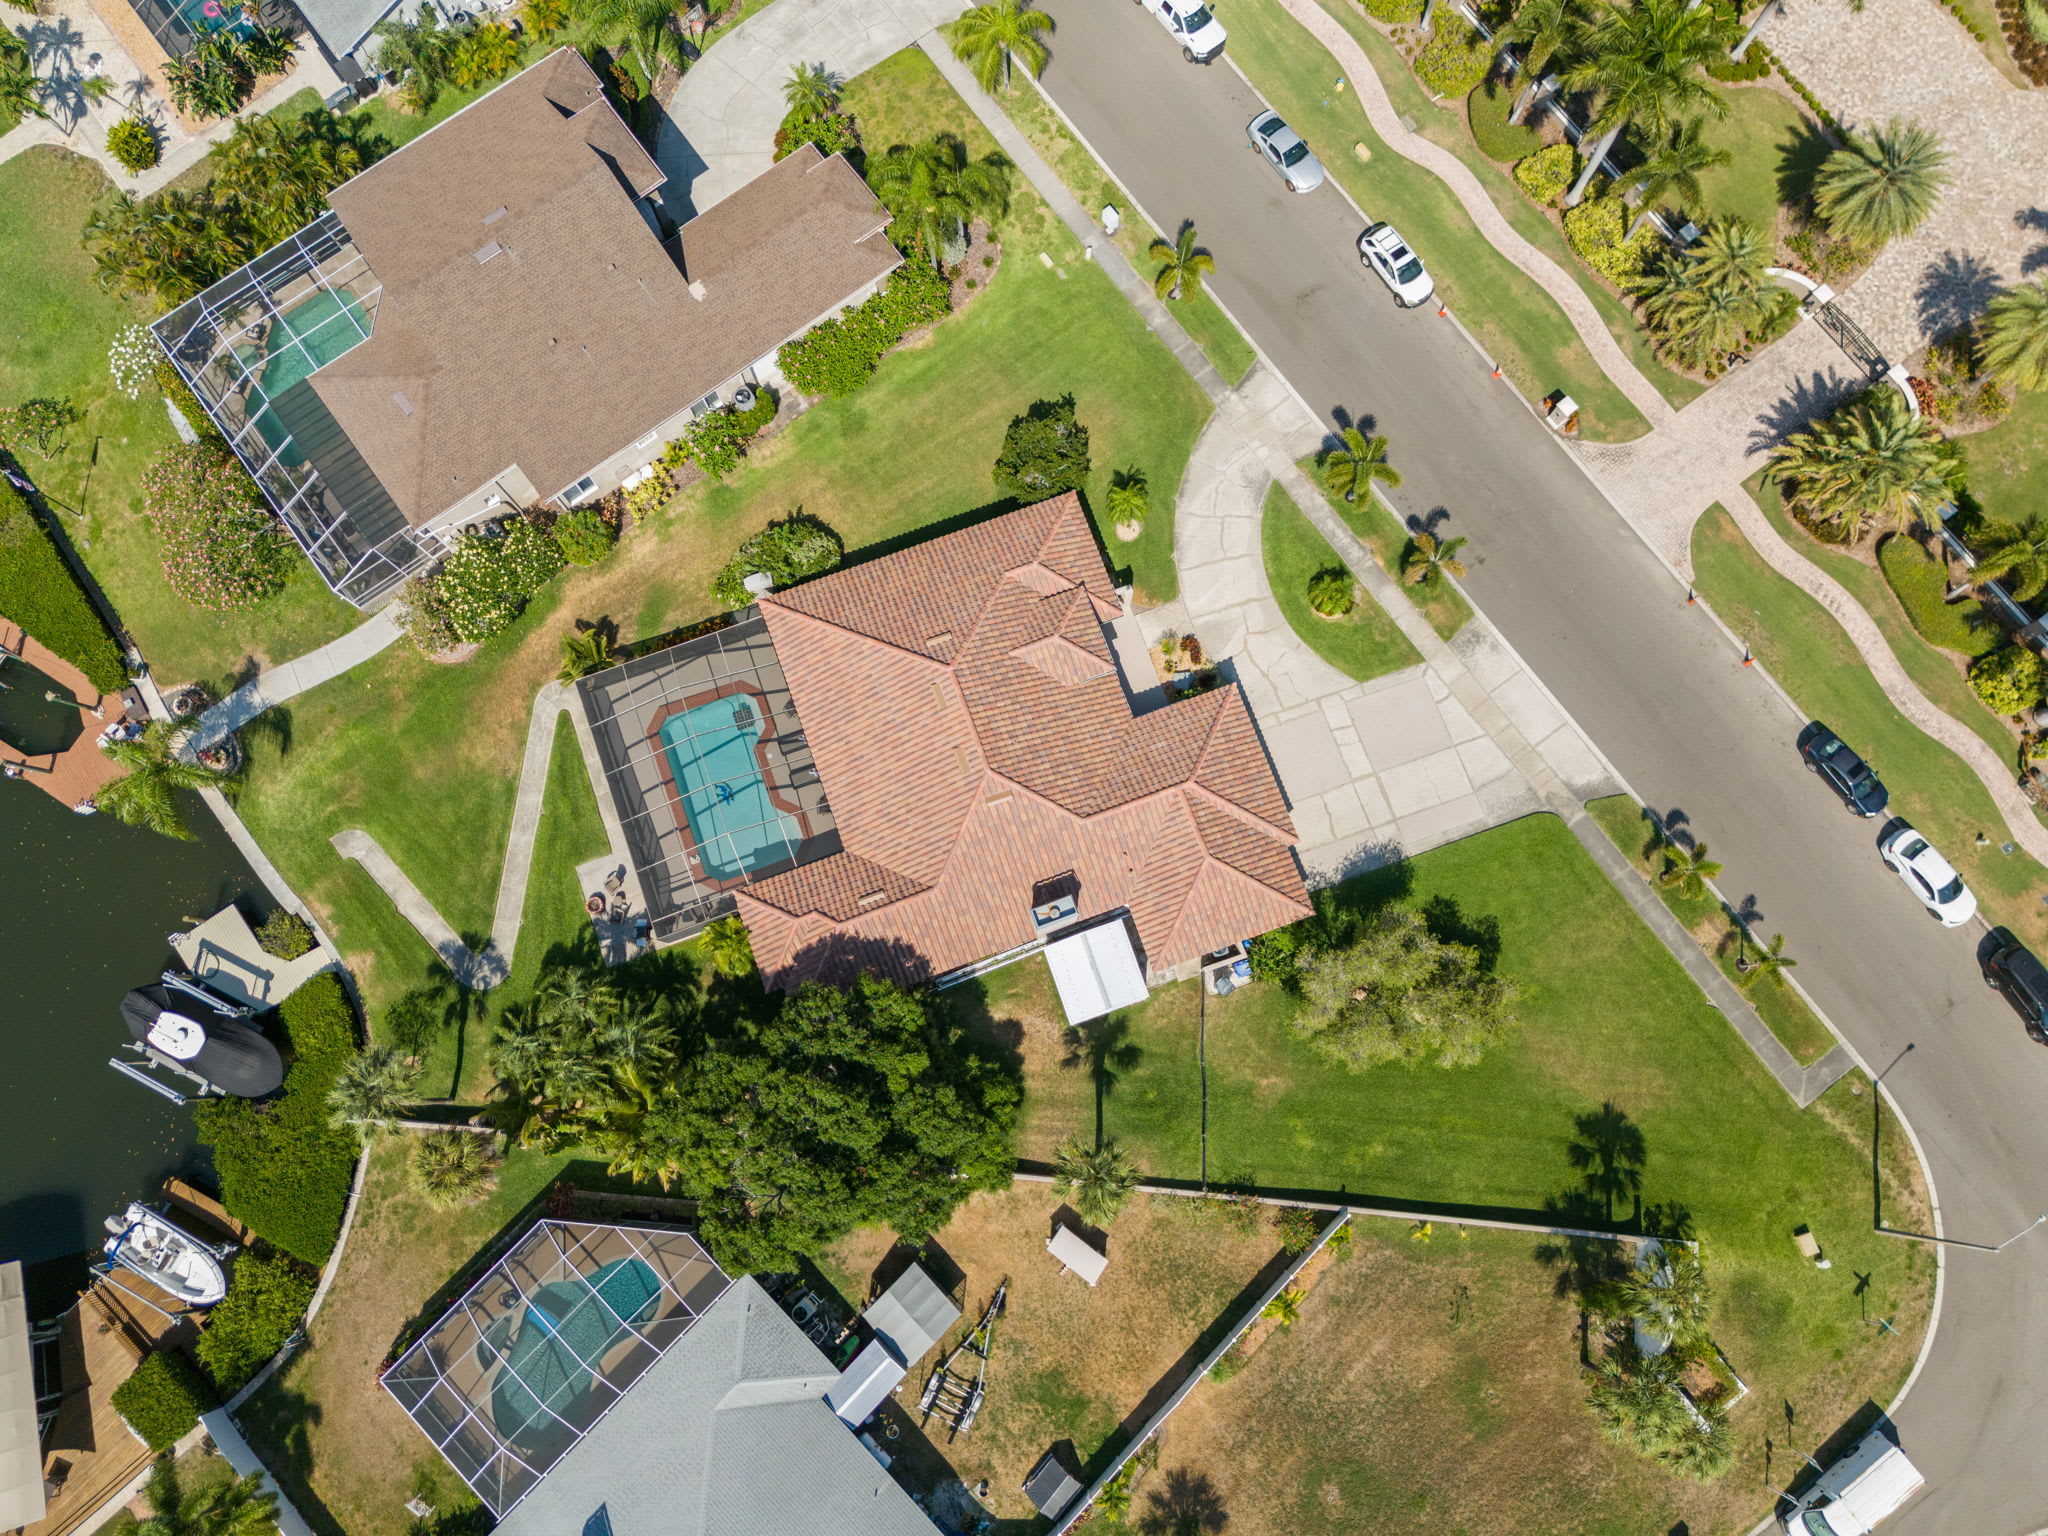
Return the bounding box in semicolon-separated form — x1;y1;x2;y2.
150;211;438;608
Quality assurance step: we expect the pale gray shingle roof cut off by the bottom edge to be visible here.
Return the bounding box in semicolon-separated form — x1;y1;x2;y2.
498;1278;934;1536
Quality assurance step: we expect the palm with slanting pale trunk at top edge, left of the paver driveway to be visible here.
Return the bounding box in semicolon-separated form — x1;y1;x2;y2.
1565;0;1739;207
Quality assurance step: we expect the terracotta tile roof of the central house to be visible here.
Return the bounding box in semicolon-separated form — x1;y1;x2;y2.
737;496;1309;985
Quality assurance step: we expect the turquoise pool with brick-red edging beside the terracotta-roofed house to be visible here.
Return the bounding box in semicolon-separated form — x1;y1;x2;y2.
662;694;803;881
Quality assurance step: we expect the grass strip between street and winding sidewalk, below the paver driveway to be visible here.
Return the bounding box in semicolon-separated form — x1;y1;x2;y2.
1692;506;2048;942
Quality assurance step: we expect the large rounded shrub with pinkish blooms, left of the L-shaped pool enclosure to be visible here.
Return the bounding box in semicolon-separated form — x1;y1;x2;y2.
141;440;293;608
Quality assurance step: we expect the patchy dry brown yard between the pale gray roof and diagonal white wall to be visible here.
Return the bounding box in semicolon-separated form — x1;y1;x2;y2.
821;1186;1284;1520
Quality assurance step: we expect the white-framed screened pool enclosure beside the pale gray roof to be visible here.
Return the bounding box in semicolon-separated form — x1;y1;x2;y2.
383;1219;731;1520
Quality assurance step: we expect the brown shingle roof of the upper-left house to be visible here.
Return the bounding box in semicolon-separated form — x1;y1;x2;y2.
313;49;901;524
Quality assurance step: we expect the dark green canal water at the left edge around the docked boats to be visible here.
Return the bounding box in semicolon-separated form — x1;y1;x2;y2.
0;774;268;1264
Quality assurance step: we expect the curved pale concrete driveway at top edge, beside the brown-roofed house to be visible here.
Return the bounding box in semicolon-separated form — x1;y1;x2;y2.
653;0;967;213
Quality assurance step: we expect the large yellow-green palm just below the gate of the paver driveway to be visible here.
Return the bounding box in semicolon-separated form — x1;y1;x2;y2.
1772;385;1962;543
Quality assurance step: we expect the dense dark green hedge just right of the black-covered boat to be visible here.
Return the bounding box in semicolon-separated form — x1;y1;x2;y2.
193;975;358;1264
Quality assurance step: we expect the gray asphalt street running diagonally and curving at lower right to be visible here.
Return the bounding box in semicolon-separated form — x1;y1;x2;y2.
1044;0;2048;1536
